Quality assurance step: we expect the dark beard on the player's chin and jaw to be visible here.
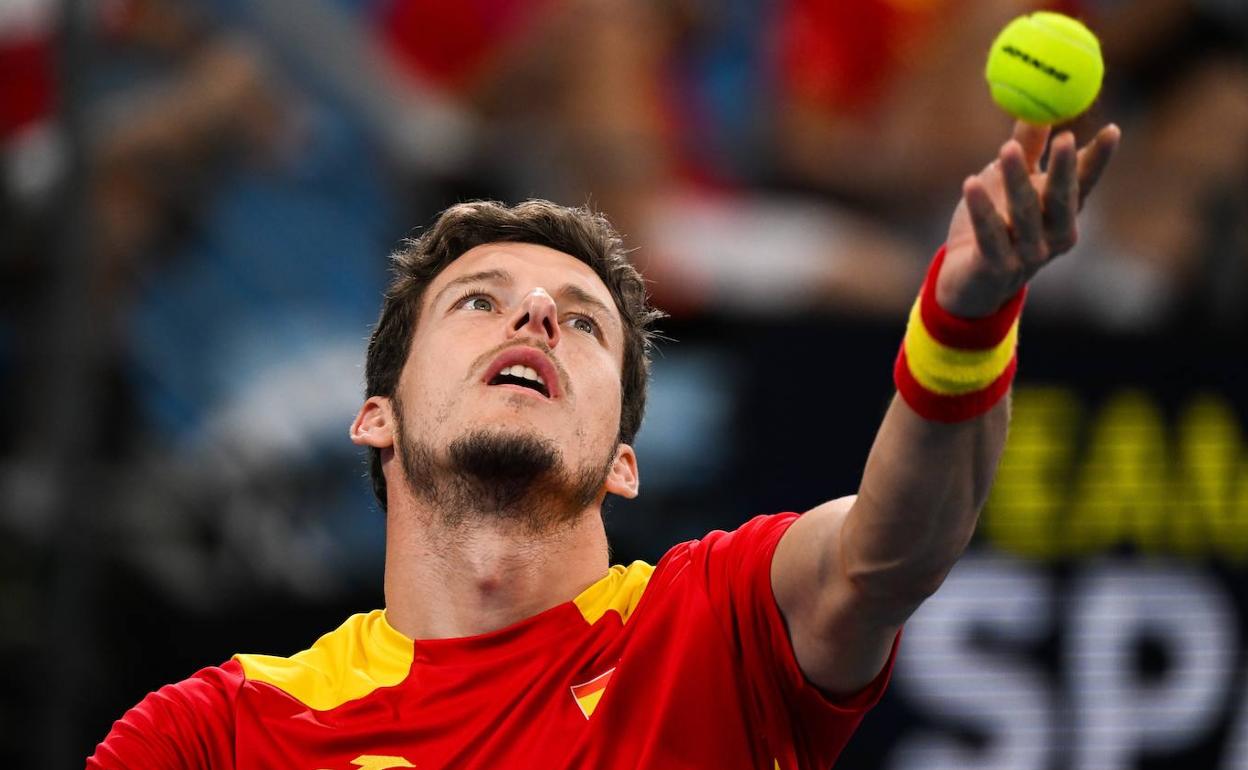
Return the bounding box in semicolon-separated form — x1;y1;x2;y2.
394;399;615;534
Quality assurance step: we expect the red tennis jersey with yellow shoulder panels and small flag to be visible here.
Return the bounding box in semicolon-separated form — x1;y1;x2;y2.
87;514;896;770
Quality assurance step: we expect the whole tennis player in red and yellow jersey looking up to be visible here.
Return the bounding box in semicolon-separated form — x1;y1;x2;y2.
87;119;1118;770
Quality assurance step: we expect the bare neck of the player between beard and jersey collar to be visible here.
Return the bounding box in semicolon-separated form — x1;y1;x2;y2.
386;500;609;639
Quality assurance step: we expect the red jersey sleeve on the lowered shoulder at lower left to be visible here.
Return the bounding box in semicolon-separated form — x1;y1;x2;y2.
86;660;243;770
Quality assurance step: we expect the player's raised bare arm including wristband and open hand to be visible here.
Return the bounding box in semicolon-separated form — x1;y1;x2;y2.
771;122;1119;695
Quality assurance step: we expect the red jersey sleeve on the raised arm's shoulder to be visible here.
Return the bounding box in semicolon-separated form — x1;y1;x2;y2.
693;513;897;770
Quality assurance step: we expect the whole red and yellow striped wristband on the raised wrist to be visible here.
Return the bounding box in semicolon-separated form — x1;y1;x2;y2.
892;247;1027;423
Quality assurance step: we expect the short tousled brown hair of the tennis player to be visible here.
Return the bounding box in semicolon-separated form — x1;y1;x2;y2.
364;200;664;510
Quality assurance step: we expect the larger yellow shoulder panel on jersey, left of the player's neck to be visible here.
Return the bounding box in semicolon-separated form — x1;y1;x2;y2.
235;609;412;711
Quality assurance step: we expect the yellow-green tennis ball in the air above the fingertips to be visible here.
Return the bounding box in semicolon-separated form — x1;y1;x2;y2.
983;11;1104;125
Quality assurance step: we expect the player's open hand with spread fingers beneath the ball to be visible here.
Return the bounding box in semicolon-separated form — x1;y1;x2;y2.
936;121;1121;318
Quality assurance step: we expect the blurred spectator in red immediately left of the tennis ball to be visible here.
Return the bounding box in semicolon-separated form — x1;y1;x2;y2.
775;0;1038;209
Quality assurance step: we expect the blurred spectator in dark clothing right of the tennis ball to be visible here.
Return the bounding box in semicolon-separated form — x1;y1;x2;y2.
1035;0;1248;331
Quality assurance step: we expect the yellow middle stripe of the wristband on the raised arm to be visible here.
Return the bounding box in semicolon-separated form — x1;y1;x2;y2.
905;301;1018;396
